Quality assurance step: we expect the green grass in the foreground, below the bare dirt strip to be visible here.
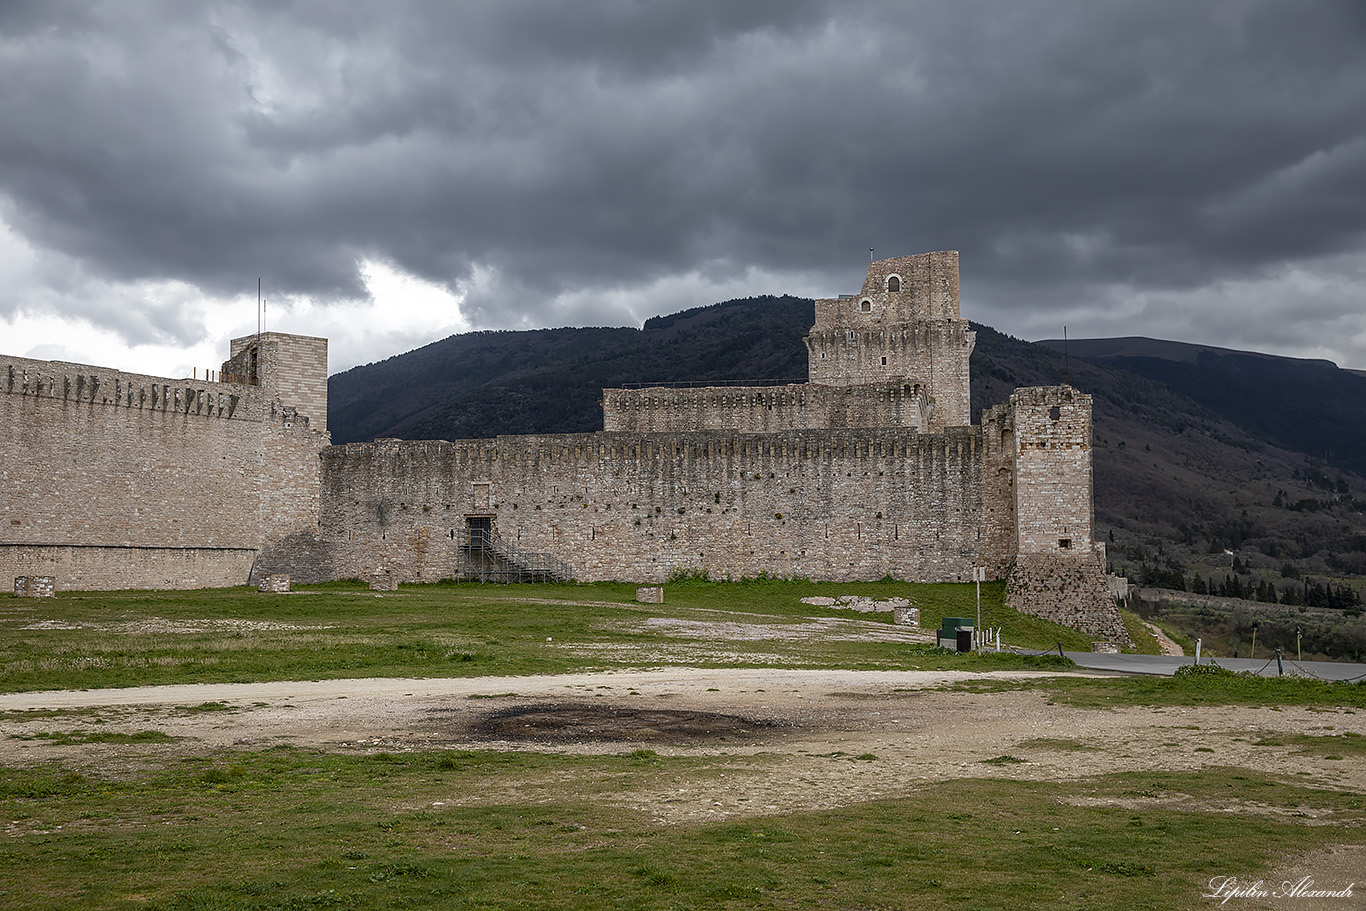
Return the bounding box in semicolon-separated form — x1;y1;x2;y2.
0;750;1366;911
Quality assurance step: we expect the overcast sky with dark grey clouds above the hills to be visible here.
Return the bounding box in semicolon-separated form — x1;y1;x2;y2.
0;0;1366;376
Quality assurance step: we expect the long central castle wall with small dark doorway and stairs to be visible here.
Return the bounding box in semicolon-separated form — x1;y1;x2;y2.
322;429;1008;582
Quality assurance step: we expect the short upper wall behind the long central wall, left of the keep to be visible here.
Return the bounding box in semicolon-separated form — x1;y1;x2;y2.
602;382;929;433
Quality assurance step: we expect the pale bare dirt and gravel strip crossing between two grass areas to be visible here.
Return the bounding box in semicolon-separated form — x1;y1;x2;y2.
0;668;1366;822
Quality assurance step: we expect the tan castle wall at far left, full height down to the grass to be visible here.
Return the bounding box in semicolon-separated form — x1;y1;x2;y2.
0;334;326;590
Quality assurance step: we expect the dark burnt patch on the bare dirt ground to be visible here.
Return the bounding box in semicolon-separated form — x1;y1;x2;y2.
470;702;784;744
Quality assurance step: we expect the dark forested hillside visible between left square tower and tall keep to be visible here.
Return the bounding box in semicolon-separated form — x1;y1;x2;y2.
328;296;816;443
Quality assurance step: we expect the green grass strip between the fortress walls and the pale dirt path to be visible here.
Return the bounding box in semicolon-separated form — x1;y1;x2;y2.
0;580;1090;692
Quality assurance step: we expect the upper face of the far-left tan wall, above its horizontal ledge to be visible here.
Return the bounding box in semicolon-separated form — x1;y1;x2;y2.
0;358;261;551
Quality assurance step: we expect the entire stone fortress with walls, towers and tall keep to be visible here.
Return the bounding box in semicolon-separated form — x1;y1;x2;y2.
0;251;1127;642
